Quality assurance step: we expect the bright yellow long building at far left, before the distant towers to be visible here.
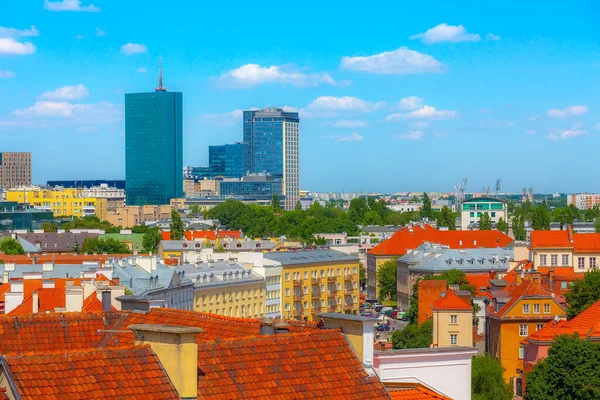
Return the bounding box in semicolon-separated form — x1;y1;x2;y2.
6;188;97;217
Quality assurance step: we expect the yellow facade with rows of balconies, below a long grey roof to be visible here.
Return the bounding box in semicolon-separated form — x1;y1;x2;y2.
281;262;359;321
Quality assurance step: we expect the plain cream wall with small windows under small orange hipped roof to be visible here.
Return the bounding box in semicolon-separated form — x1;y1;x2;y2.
433;310;473;347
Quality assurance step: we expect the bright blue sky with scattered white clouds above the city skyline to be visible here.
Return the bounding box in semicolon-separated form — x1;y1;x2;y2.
0;0;600;192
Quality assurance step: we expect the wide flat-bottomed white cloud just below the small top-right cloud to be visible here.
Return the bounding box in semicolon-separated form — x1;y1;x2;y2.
340;47;446;75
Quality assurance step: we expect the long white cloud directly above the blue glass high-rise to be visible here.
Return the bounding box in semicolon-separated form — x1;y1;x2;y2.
216;64;351;88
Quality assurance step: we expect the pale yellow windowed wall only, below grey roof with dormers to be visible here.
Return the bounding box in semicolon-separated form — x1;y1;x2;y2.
194;281;265;318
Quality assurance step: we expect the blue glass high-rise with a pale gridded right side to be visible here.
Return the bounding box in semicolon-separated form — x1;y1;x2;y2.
244;107;300;210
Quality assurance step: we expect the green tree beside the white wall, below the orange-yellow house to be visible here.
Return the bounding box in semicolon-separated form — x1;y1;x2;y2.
471;355;512;400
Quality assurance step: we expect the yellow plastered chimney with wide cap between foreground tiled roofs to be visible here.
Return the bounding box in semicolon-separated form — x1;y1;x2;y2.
128;324;202;399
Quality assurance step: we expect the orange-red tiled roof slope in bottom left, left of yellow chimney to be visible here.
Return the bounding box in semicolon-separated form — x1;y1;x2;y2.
5;346;179;399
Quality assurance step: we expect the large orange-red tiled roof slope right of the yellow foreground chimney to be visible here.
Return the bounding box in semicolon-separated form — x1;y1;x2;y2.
198;330;389;399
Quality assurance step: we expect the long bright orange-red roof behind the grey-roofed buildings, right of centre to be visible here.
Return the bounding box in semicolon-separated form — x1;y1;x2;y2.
369;225;512;256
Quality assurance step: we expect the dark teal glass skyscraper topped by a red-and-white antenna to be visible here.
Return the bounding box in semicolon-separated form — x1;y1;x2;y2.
125;63;183;205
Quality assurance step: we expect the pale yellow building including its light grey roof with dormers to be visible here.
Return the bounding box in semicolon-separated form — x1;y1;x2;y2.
182;260;265;318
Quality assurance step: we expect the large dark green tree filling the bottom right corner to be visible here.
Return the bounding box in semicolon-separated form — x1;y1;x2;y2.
525;334;600;400
